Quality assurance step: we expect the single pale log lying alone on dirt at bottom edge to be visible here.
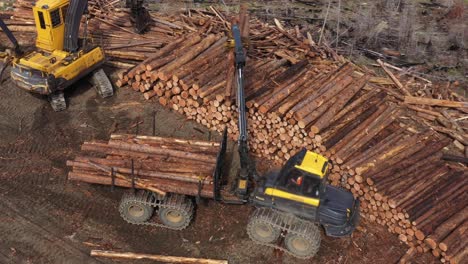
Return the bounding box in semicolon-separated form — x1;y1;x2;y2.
91;250;228;264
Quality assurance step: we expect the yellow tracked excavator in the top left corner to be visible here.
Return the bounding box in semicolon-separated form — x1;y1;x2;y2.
0;0;114;111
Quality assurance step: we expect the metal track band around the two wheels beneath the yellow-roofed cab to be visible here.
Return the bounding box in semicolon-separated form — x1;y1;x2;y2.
247;208;321;259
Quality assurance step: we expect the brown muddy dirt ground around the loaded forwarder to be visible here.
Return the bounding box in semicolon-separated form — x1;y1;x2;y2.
0;69;433;263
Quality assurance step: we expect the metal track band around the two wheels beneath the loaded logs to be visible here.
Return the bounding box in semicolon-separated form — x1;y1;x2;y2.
119;191;194;230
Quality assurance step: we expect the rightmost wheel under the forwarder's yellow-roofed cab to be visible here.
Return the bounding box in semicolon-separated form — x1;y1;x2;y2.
284;225;321;258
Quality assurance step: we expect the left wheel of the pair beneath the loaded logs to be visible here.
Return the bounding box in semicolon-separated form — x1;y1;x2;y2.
119;193;154;224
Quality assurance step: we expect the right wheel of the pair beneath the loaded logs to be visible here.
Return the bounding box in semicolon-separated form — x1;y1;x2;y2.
158;194;194;230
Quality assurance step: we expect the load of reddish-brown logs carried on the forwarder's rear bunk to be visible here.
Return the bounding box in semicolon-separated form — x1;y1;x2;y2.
67;134;220;198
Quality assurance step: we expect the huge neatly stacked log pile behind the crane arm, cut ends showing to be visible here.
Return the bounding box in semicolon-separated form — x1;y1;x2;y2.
112;7;468;263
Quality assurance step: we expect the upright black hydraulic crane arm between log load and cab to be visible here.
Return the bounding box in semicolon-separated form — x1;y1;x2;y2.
232;25;257;198
